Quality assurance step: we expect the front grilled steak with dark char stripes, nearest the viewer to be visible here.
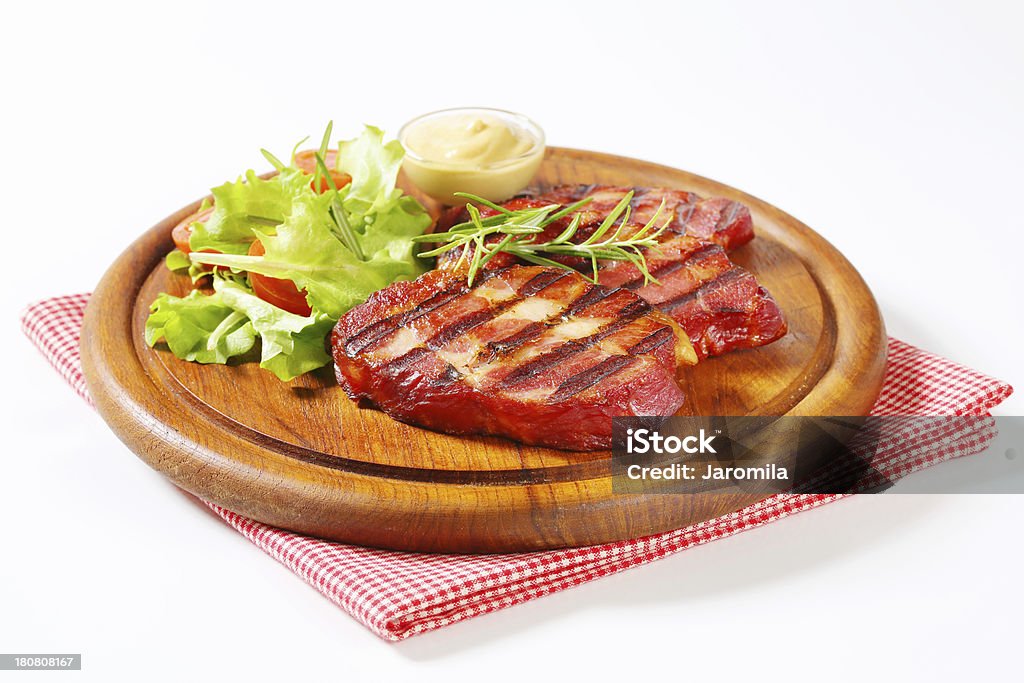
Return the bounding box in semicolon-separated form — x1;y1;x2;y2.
332;265;696;451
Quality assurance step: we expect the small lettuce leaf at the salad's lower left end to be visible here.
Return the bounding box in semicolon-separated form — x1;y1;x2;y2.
145;290;256;364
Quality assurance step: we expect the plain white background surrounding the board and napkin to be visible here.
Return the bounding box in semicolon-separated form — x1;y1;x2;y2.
0;0;1024;681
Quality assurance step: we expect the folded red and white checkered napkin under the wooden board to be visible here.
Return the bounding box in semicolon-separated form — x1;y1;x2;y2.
22;294;1013;640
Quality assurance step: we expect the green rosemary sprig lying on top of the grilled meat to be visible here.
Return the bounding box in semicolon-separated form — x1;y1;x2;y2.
413;191;672;286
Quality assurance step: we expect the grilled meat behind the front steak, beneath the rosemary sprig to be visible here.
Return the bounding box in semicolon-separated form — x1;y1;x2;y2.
438;185;786;358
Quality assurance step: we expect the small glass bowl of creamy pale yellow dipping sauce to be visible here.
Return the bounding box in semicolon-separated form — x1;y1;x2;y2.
398;108;544;205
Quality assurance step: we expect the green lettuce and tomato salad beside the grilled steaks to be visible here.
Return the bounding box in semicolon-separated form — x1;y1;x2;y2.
145;124;431;381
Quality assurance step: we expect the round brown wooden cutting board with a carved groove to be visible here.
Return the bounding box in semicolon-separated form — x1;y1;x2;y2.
82;147;886;553
